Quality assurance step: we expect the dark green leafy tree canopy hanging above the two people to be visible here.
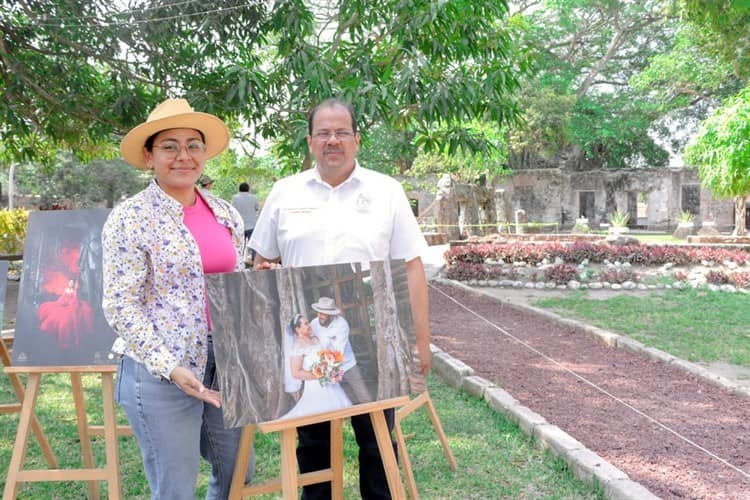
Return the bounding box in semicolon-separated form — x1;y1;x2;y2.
0;0;524;168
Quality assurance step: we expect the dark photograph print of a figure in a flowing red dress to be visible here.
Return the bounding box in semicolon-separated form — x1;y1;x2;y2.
13;209;115;366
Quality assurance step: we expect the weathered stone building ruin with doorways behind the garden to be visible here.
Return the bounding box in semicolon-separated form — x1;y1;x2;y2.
414;168;750;240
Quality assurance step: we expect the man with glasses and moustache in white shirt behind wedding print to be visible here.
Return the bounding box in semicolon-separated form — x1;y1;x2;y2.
250;99;431;499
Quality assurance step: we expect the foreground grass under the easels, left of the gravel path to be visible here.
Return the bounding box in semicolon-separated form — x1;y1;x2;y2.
0;375;603;499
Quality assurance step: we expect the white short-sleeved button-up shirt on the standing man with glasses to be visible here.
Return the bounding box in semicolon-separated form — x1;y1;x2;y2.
250;165;427;267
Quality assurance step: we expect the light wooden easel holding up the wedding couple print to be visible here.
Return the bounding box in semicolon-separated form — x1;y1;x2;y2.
229;396;409;500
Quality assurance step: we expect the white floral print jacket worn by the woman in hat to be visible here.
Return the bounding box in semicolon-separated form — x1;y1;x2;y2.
102;181;244;380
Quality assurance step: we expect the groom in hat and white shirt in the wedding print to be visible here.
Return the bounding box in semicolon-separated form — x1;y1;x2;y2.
310;297;372;405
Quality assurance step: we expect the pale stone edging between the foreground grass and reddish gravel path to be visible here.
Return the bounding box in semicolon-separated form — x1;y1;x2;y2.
430;344;659;500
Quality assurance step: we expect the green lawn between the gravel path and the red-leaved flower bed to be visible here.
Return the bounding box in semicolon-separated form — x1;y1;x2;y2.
534;289;750;367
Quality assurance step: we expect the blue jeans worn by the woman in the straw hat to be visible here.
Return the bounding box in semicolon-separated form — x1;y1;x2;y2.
115;344;255;500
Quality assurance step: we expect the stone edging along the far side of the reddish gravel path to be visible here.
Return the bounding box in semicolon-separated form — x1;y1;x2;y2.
433;278;750;397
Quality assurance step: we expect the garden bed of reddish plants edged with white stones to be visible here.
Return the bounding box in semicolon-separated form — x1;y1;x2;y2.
445;241;750;292
